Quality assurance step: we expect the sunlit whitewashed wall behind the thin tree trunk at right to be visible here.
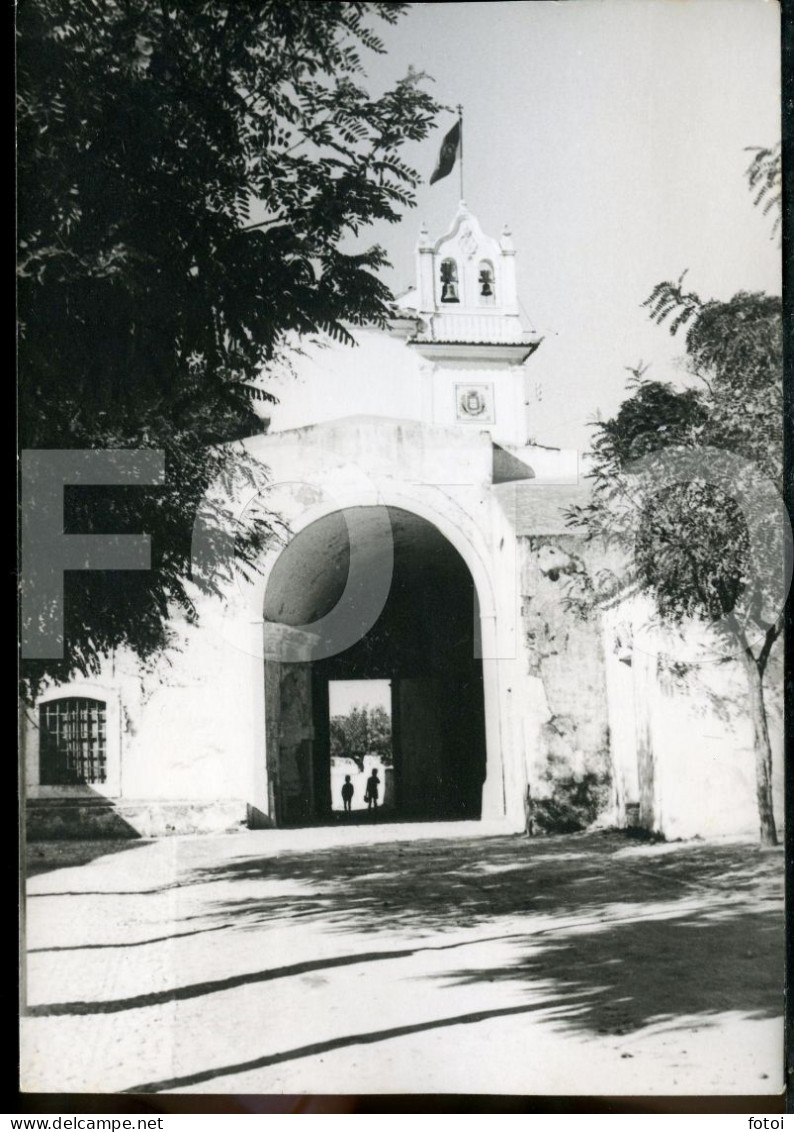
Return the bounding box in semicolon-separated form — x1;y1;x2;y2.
604;595;783;838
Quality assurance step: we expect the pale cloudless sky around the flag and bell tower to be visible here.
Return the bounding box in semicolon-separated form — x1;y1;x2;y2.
348;0;780;448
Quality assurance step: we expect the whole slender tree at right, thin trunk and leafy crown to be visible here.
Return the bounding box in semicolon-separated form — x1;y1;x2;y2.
569;267;786;843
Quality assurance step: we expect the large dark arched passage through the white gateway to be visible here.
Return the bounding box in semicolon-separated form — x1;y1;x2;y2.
264;507;486;825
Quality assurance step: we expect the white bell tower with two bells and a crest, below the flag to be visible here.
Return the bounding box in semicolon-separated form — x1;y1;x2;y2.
399;201;540;447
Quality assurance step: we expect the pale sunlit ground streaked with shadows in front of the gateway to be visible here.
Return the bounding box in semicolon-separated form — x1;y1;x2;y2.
22;824;783;1095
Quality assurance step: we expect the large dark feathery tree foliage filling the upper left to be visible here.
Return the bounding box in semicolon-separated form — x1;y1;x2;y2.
17;0;438;679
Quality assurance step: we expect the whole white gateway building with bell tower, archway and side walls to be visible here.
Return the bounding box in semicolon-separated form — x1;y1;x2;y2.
23;204;783;838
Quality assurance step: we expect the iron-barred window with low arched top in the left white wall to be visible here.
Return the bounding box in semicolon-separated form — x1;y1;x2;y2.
39;697;108;786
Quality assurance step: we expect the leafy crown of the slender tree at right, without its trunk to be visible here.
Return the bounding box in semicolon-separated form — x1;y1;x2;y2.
570;283;783;647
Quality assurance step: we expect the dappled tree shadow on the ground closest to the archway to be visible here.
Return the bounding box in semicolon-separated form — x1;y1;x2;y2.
189;834;783;935
